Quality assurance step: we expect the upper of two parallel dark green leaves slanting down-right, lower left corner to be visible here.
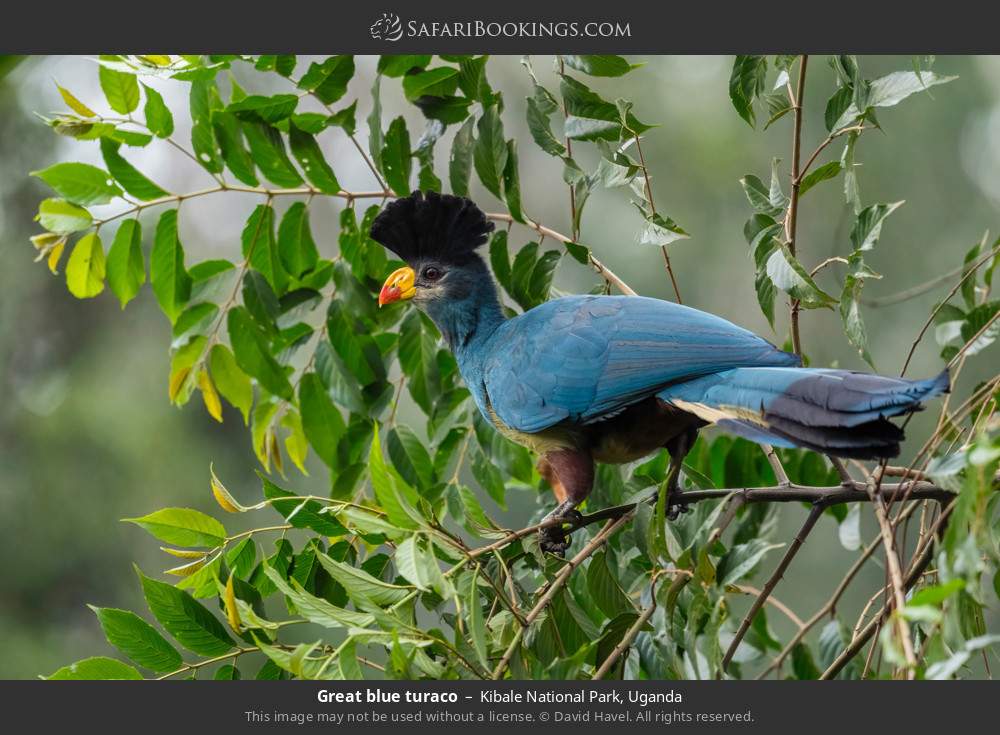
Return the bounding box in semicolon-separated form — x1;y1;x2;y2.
135;567;234;656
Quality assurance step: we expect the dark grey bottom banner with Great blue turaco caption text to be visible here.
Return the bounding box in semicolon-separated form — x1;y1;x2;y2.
0;681;995;735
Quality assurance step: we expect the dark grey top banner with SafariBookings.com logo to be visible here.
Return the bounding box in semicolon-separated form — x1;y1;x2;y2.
0;0;1000;54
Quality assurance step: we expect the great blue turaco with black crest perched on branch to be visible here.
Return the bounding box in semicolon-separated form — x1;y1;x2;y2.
370;191;949;555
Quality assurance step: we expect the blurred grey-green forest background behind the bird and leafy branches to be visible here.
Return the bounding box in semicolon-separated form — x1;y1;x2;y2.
0;56;1000;678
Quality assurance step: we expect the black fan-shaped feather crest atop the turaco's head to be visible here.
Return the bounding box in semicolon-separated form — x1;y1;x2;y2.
371;191;493;264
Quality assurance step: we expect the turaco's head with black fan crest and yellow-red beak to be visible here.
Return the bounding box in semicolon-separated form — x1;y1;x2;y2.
371;191;493;310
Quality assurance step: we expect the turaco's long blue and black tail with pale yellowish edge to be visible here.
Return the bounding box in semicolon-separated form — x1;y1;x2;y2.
657;367;949;459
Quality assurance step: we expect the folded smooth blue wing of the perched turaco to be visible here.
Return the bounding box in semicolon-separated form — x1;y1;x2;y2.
482;296;799;433
